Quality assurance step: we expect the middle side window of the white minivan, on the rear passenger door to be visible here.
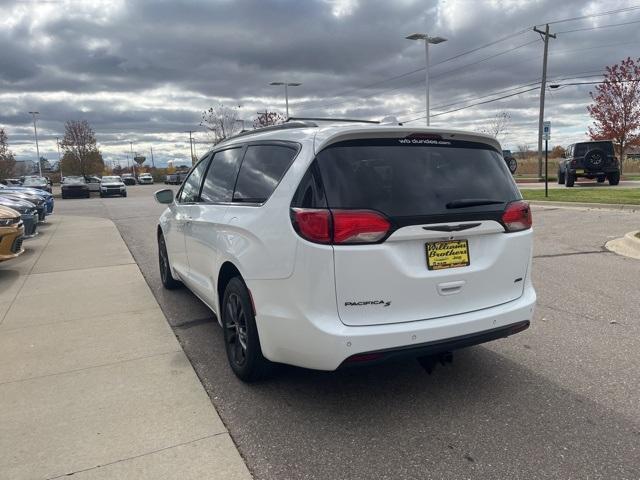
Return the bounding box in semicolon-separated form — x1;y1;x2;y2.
200;147;242;203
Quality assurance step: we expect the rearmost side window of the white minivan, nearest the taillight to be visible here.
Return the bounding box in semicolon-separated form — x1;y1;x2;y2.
233;145;297;203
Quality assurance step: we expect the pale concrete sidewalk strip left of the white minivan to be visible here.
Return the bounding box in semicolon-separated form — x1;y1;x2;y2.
0;216;251;480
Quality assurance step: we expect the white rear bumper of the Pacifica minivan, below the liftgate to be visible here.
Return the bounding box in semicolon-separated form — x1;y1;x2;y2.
252;282;536;370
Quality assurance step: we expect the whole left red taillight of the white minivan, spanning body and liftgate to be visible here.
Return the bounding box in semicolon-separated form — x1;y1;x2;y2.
291;208;391;245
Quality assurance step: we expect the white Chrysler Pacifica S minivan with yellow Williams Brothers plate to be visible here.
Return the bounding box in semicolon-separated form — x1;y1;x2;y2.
156;122;536;381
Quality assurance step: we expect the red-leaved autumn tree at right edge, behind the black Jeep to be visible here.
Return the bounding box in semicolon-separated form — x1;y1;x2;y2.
587;57;640;171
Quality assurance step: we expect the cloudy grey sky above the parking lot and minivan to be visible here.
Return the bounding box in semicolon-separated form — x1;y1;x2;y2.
0;0;640;168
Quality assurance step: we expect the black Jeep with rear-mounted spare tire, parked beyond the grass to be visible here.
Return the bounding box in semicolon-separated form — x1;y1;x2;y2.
558;141;620;187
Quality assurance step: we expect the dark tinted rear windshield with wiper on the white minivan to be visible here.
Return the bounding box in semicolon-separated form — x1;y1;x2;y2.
317;139;521;217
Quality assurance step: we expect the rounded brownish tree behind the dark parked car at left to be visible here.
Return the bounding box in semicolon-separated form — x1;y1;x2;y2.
60;120;104;175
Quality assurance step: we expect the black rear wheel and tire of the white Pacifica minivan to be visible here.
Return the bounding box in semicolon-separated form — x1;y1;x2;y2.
220;277;273;382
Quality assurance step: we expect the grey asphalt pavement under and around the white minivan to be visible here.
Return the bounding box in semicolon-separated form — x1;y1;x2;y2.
56;185;640;479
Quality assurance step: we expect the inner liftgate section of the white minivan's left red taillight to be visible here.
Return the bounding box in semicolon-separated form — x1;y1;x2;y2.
331;210;391;243
